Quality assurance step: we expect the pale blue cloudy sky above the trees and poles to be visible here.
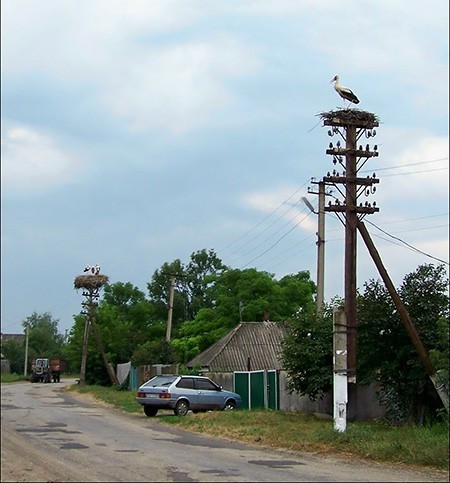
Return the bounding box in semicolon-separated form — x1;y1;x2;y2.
1;0;449;333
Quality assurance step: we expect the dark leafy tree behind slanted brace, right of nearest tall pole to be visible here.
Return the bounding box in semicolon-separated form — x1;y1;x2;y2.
357;265;449;423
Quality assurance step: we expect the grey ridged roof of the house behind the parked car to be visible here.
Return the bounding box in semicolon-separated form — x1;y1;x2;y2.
187;321;288;372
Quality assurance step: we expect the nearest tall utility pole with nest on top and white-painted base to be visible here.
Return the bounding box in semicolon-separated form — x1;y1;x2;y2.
321;109;379;430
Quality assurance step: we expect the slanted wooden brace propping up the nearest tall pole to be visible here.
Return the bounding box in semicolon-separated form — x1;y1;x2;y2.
357;221;449;411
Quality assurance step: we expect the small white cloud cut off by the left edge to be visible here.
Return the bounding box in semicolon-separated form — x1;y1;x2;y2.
2;125;80;194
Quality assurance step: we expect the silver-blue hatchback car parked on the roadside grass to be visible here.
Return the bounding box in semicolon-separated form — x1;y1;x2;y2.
136;375;242;416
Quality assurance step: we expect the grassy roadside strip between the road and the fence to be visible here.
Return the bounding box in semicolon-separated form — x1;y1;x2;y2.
64;385;449;471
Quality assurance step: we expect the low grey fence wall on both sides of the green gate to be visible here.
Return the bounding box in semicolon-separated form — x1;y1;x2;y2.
204;371;385;421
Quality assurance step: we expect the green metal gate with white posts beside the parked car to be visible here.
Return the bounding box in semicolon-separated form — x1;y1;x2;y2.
233;370;280;409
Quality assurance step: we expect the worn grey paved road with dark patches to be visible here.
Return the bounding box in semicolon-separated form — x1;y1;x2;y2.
1;380;448;482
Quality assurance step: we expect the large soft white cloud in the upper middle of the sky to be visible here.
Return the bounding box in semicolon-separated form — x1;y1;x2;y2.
101;36;258;132
